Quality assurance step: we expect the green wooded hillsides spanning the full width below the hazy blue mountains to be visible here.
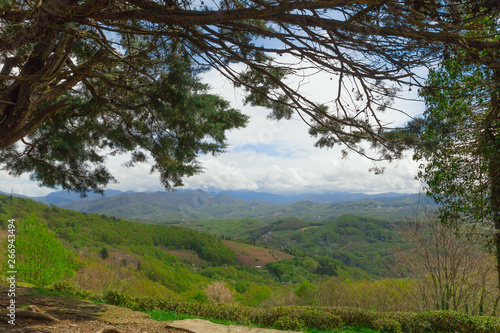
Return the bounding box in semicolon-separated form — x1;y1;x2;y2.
0;195;499;333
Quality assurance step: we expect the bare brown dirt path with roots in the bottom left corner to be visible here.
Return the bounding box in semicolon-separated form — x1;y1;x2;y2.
0;285;296;333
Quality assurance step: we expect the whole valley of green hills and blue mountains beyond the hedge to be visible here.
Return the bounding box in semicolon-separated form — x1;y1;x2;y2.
0;191;496;328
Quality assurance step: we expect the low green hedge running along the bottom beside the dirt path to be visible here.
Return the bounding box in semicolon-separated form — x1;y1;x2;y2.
52;282;500;333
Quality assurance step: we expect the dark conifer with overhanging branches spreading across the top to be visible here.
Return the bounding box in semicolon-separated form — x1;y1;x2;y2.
0;0;500;193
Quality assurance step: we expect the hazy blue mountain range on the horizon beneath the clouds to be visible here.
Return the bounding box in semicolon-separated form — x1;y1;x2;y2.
1;190;435;224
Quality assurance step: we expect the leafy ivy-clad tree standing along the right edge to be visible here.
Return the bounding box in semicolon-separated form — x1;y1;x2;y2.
398;9;500;285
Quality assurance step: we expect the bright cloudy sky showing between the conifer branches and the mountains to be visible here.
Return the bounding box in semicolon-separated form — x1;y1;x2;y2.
0;63;423;196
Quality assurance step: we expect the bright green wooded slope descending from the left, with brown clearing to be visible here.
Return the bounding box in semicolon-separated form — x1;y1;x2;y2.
0;195;378;306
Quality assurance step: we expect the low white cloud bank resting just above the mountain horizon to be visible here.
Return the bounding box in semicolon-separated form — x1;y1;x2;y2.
180;136;420;193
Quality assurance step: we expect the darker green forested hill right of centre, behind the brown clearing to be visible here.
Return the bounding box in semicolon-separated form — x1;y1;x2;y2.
196;214;402;276
